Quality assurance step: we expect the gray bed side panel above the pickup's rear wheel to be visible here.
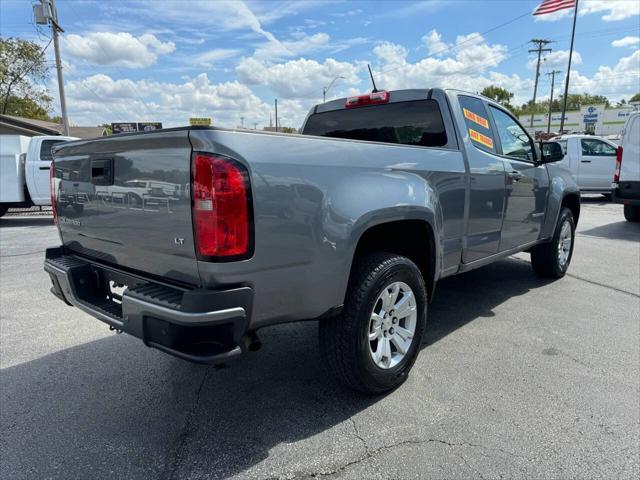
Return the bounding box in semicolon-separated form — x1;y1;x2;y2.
190;130;465;328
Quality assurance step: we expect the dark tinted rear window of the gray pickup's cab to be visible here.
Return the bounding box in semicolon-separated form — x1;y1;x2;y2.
303;100;447;147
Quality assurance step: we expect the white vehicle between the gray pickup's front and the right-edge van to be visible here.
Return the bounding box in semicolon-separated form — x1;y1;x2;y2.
552;135;618;197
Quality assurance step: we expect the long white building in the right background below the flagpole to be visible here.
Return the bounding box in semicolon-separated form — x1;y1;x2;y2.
519;105;638;135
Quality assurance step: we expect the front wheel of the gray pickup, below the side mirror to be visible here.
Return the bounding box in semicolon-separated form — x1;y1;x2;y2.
531;207;576;278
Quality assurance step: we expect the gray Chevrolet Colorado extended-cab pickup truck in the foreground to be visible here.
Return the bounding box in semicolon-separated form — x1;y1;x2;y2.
44;89;580;393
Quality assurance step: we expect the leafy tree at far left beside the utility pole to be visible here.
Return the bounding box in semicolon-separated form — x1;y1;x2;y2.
0;37;52;120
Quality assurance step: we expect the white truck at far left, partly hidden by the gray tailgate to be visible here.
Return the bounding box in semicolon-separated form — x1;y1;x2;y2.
0;135;77;217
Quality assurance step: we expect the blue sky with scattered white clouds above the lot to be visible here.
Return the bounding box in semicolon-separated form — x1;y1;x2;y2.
0;0;640;129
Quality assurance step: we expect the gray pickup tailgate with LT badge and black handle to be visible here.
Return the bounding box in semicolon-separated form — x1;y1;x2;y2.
53;129;200;285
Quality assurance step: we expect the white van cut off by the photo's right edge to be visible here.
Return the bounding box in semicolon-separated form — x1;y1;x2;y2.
611;112;640;222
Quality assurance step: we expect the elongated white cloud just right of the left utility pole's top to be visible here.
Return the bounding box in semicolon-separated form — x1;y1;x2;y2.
63;32;175;68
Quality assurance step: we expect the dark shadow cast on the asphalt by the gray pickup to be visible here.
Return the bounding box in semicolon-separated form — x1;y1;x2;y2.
0;259;545;478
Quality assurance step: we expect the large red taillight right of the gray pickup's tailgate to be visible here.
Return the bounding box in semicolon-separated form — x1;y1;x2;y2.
192;153;253;259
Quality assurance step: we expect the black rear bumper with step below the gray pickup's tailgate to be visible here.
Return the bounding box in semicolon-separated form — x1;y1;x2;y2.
44;247;253;363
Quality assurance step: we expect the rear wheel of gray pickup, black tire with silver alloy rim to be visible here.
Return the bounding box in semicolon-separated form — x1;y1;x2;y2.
319;253;427;395
